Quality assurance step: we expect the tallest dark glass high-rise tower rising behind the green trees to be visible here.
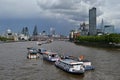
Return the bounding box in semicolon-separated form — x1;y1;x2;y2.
89;7;96;35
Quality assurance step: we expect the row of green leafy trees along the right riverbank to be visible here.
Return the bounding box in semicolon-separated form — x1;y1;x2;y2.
75;34;120;43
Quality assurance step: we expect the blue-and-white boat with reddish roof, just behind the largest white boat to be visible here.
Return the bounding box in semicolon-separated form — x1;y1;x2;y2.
43;51;60;62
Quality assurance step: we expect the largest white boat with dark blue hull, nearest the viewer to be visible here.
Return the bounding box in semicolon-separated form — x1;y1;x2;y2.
55;58;85;74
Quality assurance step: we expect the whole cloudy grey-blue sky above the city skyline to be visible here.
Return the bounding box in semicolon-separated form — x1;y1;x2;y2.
0;0;120;34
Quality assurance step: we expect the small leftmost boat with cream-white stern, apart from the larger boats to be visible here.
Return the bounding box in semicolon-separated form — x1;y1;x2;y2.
27;48;39;59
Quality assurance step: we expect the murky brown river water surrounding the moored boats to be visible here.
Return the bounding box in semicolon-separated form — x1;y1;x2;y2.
0;41;120;80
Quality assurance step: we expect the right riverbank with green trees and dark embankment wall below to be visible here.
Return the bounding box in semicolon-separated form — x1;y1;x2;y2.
73;34;120;48
